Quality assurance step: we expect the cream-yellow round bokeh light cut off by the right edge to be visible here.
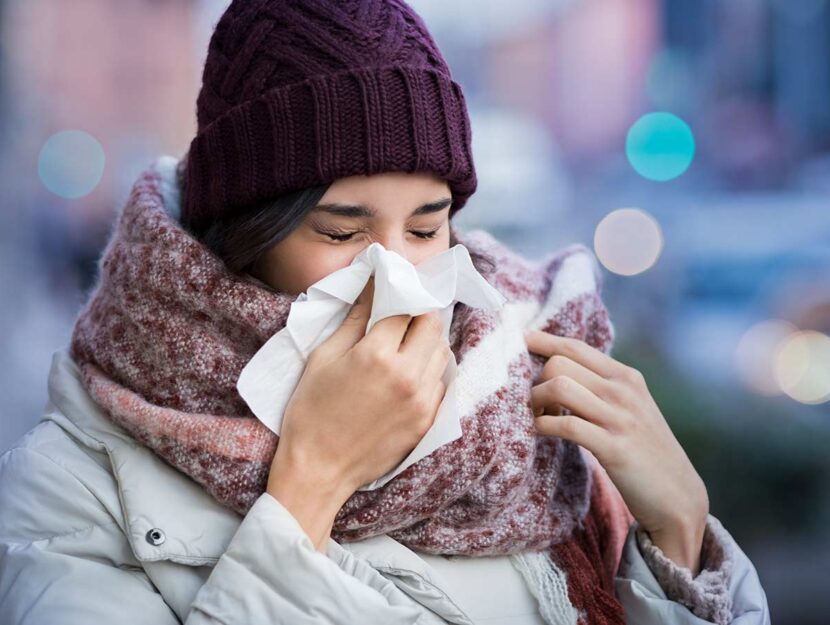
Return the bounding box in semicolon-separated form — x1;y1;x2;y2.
775;330;830;404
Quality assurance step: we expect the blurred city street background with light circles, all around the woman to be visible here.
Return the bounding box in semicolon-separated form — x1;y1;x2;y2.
0;0;830;625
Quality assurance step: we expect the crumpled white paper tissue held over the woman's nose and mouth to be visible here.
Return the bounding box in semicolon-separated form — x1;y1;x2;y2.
237;243;507;490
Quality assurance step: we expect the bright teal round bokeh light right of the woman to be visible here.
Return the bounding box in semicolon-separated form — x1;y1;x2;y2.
625;112;695;182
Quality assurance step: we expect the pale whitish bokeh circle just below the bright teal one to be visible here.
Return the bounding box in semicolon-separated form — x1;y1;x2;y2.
594;208;663;276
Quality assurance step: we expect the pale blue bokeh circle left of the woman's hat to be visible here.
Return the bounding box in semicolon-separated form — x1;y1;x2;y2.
37;130;106;199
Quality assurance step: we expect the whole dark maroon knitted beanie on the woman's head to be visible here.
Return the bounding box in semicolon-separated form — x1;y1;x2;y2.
182;0;476;231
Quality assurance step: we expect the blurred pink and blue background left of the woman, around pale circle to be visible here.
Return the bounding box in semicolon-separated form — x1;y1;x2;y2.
0;0;218;448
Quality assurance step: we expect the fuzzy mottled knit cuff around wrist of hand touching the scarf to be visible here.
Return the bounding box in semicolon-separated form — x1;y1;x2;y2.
635;514;734;625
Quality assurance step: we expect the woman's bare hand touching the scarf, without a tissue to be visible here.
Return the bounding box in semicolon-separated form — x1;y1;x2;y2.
525;330;709;574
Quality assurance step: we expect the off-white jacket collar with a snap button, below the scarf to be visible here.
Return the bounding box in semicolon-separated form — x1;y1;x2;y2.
43;347;478;625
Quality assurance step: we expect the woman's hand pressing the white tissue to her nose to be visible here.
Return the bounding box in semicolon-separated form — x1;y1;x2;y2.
269;277;450;501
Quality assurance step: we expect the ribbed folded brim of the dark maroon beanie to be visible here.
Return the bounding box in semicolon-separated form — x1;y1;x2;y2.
183;65;477;229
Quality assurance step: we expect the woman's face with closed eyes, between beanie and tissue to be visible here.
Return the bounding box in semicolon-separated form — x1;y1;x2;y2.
251;172;452;295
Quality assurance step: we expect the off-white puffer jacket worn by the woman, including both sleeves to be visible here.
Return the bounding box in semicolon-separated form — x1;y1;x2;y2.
0;349;770;625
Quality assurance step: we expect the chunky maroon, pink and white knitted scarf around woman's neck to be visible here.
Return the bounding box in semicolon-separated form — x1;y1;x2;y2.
71;156;633;625
